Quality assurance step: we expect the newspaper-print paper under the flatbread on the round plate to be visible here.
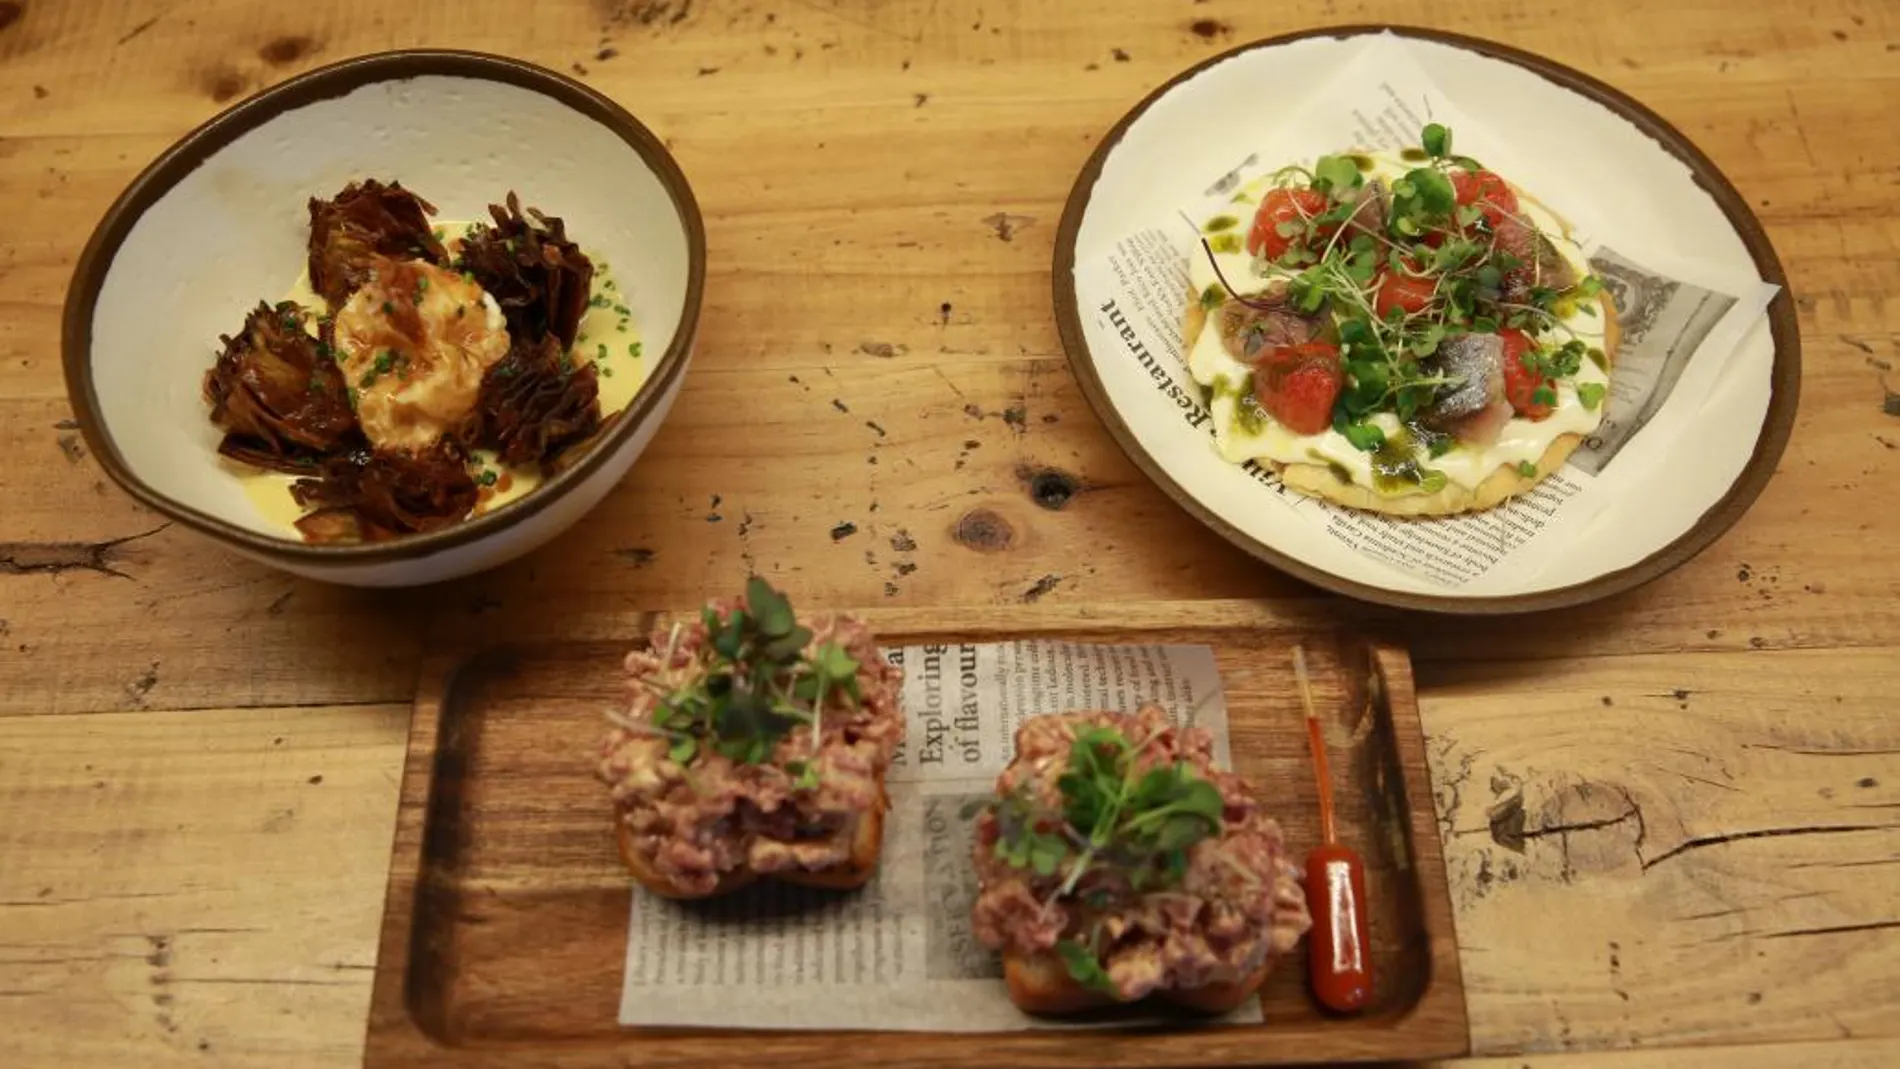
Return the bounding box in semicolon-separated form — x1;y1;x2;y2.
1075;36;1777;594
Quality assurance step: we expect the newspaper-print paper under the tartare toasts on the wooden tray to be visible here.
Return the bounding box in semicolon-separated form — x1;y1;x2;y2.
619;642;1260;1031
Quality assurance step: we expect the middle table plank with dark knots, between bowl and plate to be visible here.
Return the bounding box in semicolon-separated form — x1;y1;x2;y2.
0;334;1900;714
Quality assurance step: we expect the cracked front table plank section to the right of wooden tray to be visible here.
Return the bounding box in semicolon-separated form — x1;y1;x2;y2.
1425;647;1900;1050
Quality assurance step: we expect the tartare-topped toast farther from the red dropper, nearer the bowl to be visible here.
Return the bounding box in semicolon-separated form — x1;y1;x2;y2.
597;577;904;898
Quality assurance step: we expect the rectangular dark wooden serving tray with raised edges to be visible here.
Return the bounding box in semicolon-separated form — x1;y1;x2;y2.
365;606;1471;1069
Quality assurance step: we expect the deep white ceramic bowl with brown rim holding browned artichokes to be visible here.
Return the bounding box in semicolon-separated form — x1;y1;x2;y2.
63;51;705;587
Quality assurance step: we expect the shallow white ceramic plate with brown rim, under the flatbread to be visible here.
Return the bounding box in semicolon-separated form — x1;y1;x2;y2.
1053;27;1799;613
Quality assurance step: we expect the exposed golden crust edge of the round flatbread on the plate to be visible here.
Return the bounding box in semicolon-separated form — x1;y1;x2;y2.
1182;291;1621;516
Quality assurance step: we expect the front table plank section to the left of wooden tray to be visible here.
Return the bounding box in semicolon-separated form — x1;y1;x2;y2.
0;706;409;1065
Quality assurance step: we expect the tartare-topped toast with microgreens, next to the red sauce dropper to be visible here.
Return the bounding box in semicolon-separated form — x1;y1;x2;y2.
973;704;1311;1014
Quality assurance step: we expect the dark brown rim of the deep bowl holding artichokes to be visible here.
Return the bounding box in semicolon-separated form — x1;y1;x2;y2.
61;49;705;564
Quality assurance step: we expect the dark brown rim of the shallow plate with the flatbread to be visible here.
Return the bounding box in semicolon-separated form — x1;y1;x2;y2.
1051;25;1801;615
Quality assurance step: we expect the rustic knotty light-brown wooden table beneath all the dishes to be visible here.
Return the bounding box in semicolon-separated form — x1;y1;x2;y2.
0;0;1900;1069
